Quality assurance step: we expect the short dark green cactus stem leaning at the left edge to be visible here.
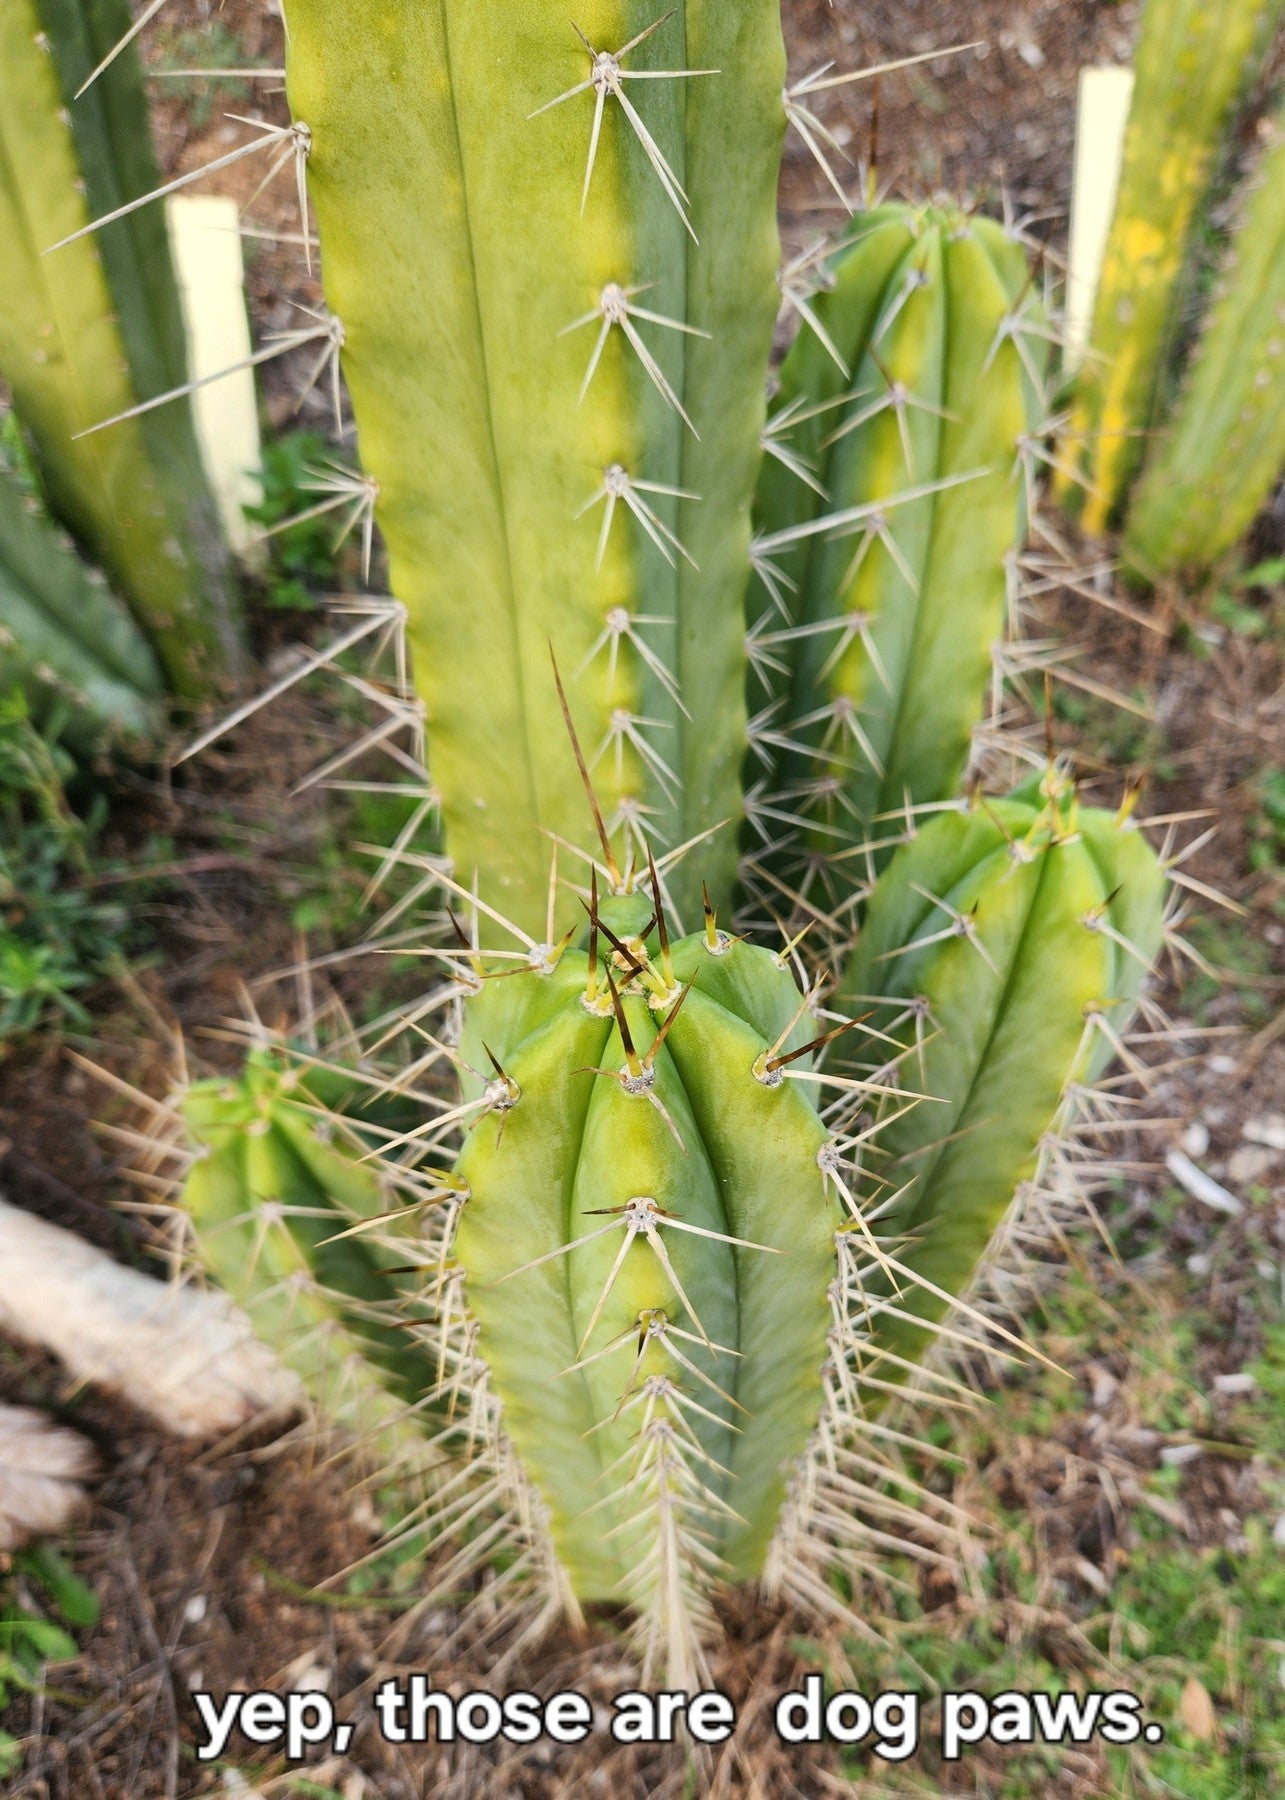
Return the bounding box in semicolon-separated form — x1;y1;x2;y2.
0;463;166;751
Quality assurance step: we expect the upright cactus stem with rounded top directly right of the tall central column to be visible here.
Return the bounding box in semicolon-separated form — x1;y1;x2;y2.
750;205;1046;902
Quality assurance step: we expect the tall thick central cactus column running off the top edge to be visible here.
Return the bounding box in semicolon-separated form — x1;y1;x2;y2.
288;0;785;931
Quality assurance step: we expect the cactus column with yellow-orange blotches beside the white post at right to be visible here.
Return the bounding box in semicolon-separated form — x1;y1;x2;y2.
1060;0;1285;533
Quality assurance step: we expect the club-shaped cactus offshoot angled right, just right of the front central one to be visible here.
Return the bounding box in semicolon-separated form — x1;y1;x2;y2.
839;772;1168;1381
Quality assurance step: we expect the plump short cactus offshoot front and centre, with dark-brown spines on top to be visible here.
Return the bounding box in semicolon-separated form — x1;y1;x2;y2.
455;904;837;1611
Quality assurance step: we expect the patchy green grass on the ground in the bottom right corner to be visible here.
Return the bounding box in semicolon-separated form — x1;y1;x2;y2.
815;1216;1285;1800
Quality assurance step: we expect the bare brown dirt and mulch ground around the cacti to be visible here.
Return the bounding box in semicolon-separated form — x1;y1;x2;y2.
0;0;1285;1800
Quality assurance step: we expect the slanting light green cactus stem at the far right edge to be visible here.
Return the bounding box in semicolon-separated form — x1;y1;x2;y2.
1125;93;1285;578
